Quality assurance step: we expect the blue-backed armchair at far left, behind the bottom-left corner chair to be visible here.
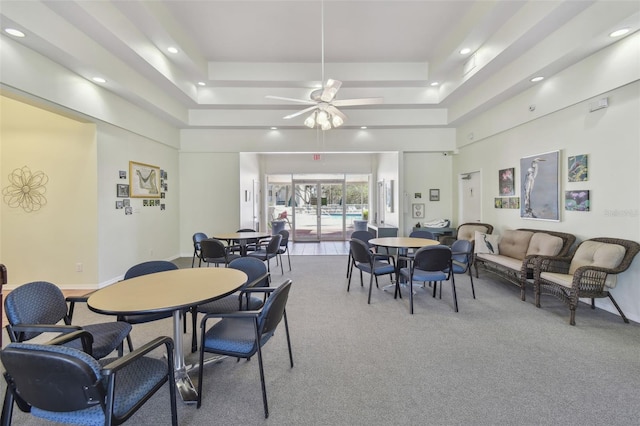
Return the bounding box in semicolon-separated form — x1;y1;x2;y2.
4;281;131;359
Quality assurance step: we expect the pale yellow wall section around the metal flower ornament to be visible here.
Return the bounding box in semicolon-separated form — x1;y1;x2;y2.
0;97;97;288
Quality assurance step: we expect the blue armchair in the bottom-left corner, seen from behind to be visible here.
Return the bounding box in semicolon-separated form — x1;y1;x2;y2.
0;330;178;426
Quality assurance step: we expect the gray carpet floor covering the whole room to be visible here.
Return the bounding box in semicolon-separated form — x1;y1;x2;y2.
1;256;640;426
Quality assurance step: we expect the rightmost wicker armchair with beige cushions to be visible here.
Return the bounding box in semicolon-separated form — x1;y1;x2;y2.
534;238;640;325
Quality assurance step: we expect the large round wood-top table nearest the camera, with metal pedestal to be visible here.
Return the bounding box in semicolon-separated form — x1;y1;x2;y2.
87;268;247;403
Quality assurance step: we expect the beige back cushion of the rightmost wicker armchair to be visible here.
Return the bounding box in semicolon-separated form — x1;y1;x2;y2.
569;240;626;288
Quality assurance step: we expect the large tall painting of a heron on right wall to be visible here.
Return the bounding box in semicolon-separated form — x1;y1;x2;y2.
520;151;560;220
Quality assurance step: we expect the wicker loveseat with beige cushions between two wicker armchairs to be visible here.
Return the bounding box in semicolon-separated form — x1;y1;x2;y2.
474;228;576;300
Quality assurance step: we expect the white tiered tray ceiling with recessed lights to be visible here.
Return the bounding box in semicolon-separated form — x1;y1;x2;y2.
0;0;640;128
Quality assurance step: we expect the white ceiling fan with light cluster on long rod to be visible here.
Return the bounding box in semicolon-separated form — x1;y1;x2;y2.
266;1;384;130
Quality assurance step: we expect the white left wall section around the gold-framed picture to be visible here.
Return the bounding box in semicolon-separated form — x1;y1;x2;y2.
97;123;181;285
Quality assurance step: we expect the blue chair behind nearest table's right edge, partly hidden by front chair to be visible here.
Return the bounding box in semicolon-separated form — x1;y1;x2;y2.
191;256;269;352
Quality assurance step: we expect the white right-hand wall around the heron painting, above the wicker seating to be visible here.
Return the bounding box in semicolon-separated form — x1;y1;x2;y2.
454;82;640;321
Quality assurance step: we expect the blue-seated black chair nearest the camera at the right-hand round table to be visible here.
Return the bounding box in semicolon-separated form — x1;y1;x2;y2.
400;245;458;314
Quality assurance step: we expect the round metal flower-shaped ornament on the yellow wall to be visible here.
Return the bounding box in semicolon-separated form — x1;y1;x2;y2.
2;166;49;213
